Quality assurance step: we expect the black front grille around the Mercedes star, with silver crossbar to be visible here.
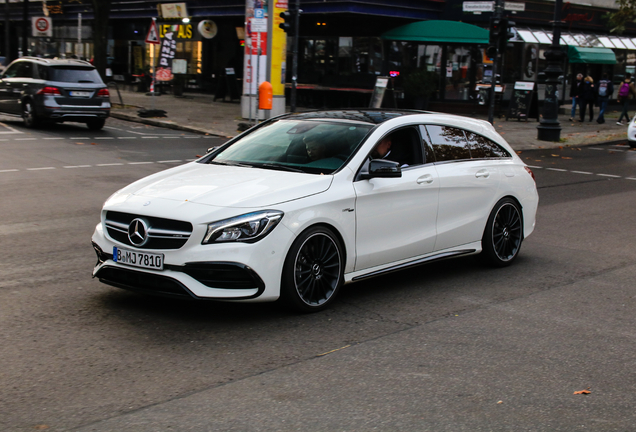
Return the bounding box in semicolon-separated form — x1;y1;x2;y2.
105;211;192;249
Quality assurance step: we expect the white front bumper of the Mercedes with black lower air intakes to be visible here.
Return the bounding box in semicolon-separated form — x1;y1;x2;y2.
92;218;293;301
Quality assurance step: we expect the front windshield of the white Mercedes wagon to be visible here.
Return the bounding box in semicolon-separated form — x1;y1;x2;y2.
207;120;373;174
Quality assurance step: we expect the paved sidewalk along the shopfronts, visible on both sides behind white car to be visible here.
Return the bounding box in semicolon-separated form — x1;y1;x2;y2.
111;88;633;150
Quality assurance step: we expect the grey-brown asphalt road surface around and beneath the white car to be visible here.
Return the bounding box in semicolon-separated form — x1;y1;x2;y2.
0;118;636;431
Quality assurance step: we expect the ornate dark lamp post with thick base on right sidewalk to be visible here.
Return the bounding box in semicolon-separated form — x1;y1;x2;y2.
537;0;565;141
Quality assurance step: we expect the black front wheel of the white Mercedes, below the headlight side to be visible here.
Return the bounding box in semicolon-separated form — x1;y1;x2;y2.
281;226;345;312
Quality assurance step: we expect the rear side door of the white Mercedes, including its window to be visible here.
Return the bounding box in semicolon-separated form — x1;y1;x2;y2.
423;125;501;251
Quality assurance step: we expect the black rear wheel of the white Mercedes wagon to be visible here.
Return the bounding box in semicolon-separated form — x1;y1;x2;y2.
481;198;523;267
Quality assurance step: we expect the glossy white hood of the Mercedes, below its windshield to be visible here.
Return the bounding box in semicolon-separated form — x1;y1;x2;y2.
120;162;333;208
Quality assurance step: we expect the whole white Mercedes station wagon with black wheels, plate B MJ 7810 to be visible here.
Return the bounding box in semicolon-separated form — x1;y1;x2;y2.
92;109;538;312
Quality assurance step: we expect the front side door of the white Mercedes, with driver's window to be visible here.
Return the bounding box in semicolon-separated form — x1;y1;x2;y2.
354;126;439;271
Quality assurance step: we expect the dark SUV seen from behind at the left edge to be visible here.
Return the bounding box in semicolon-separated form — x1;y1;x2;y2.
0;57;110;130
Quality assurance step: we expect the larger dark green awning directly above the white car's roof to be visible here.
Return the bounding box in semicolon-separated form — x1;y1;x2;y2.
381;20;488;44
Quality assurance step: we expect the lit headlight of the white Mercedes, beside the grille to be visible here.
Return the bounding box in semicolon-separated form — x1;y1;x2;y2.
201;210;284;244
